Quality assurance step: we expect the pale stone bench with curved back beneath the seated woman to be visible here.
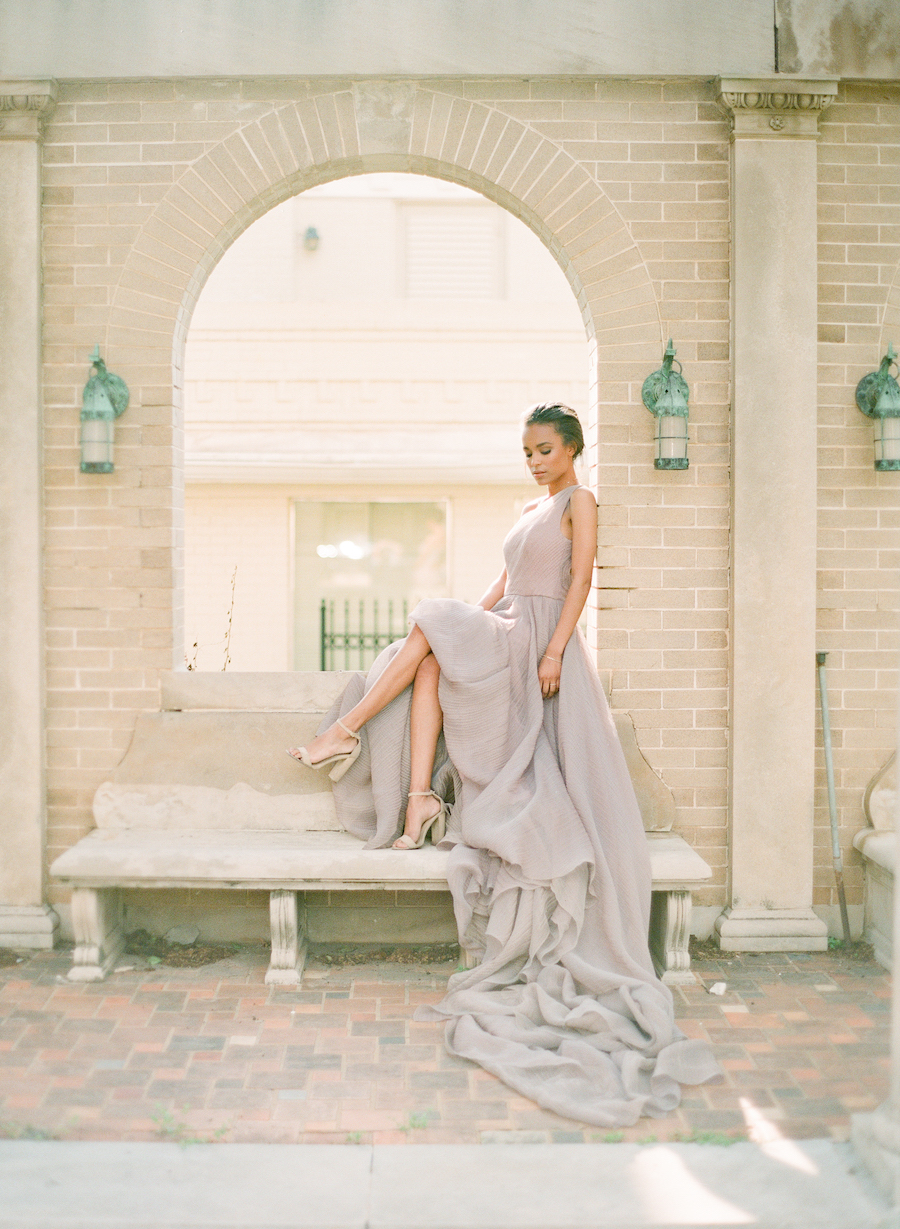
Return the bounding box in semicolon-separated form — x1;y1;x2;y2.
50;672;712;984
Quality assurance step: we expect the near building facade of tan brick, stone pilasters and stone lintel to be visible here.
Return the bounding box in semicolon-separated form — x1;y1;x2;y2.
0;0;900;949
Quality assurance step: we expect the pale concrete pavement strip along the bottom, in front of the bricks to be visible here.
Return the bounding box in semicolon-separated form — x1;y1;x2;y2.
0;1141;888;1229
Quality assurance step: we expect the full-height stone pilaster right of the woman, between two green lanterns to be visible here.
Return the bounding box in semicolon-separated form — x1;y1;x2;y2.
717;80;837;951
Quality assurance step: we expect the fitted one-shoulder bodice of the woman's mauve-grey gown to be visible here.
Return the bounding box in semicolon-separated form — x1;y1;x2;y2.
503;487;577;601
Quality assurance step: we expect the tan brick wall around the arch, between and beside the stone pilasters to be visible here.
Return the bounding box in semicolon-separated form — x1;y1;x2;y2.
36;80;900;929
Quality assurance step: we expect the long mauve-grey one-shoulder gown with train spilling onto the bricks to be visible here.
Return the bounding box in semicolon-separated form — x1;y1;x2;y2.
322;487;720;1127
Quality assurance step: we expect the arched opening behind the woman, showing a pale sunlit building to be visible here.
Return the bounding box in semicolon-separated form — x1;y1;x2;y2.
184;172;588;671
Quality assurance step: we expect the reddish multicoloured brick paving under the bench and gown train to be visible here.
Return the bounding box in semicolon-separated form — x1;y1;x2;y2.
0;950;890;1144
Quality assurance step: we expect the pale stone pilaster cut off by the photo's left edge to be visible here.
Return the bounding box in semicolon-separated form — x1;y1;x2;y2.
0;81;57;948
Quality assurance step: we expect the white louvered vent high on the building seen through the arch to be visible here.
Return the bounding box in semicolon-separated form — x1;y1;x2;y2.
403;204;504;299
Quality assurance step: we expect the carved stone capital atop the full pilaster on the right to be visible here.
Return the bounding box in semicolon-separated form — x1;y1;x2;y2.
718;77;837;139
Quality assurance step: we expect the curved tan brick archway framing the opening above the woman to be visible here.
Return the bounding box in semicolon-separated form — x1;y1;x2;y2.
100;82;663;664
